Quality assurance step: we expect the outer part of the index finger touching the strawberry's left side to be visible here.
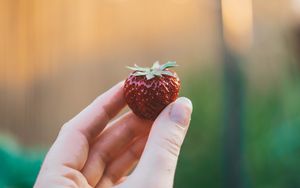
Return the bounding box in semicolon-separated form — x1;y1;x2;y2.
65;81;126;142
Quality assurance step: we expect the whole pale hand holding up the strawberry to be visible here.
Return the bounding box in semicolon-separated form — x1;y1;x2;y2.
34;83;192;188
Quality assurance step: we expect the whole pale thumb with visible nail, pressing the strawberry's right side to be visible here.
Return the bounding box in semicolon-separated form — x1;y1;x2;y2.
132;97;192;187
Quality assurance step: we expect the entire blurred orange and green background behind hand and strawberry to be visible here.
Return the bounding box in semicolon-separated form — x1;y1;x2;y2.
0;0;300;188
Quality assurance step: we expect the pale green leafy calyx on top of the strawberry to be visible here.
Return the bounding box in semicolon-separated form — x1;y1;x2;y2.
127;61;178;80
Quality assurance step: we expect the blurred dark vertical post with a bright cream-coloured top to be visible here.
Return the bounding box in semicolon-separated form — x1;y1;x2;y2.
217;0;252;188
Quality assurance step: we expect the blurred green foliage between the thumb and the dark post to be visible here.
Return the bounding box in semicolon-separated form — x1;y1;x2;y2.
175;65;223;188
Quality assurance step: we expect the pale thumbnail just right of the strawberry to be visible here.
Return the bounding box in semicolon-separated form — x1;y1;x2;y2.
170;97;193;126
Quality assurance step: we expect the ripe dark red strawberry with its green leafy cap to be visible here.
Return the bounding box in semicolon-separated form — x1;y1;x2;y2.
124;61;180;120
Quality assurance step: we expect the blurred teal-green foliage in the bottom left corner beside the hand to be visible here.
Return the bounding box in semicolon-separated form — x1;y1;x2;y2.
0;135;45;188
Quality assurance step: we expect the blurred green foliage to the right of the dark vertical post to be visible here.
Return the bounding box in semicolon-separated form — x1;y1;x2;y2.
244;70;300;188
